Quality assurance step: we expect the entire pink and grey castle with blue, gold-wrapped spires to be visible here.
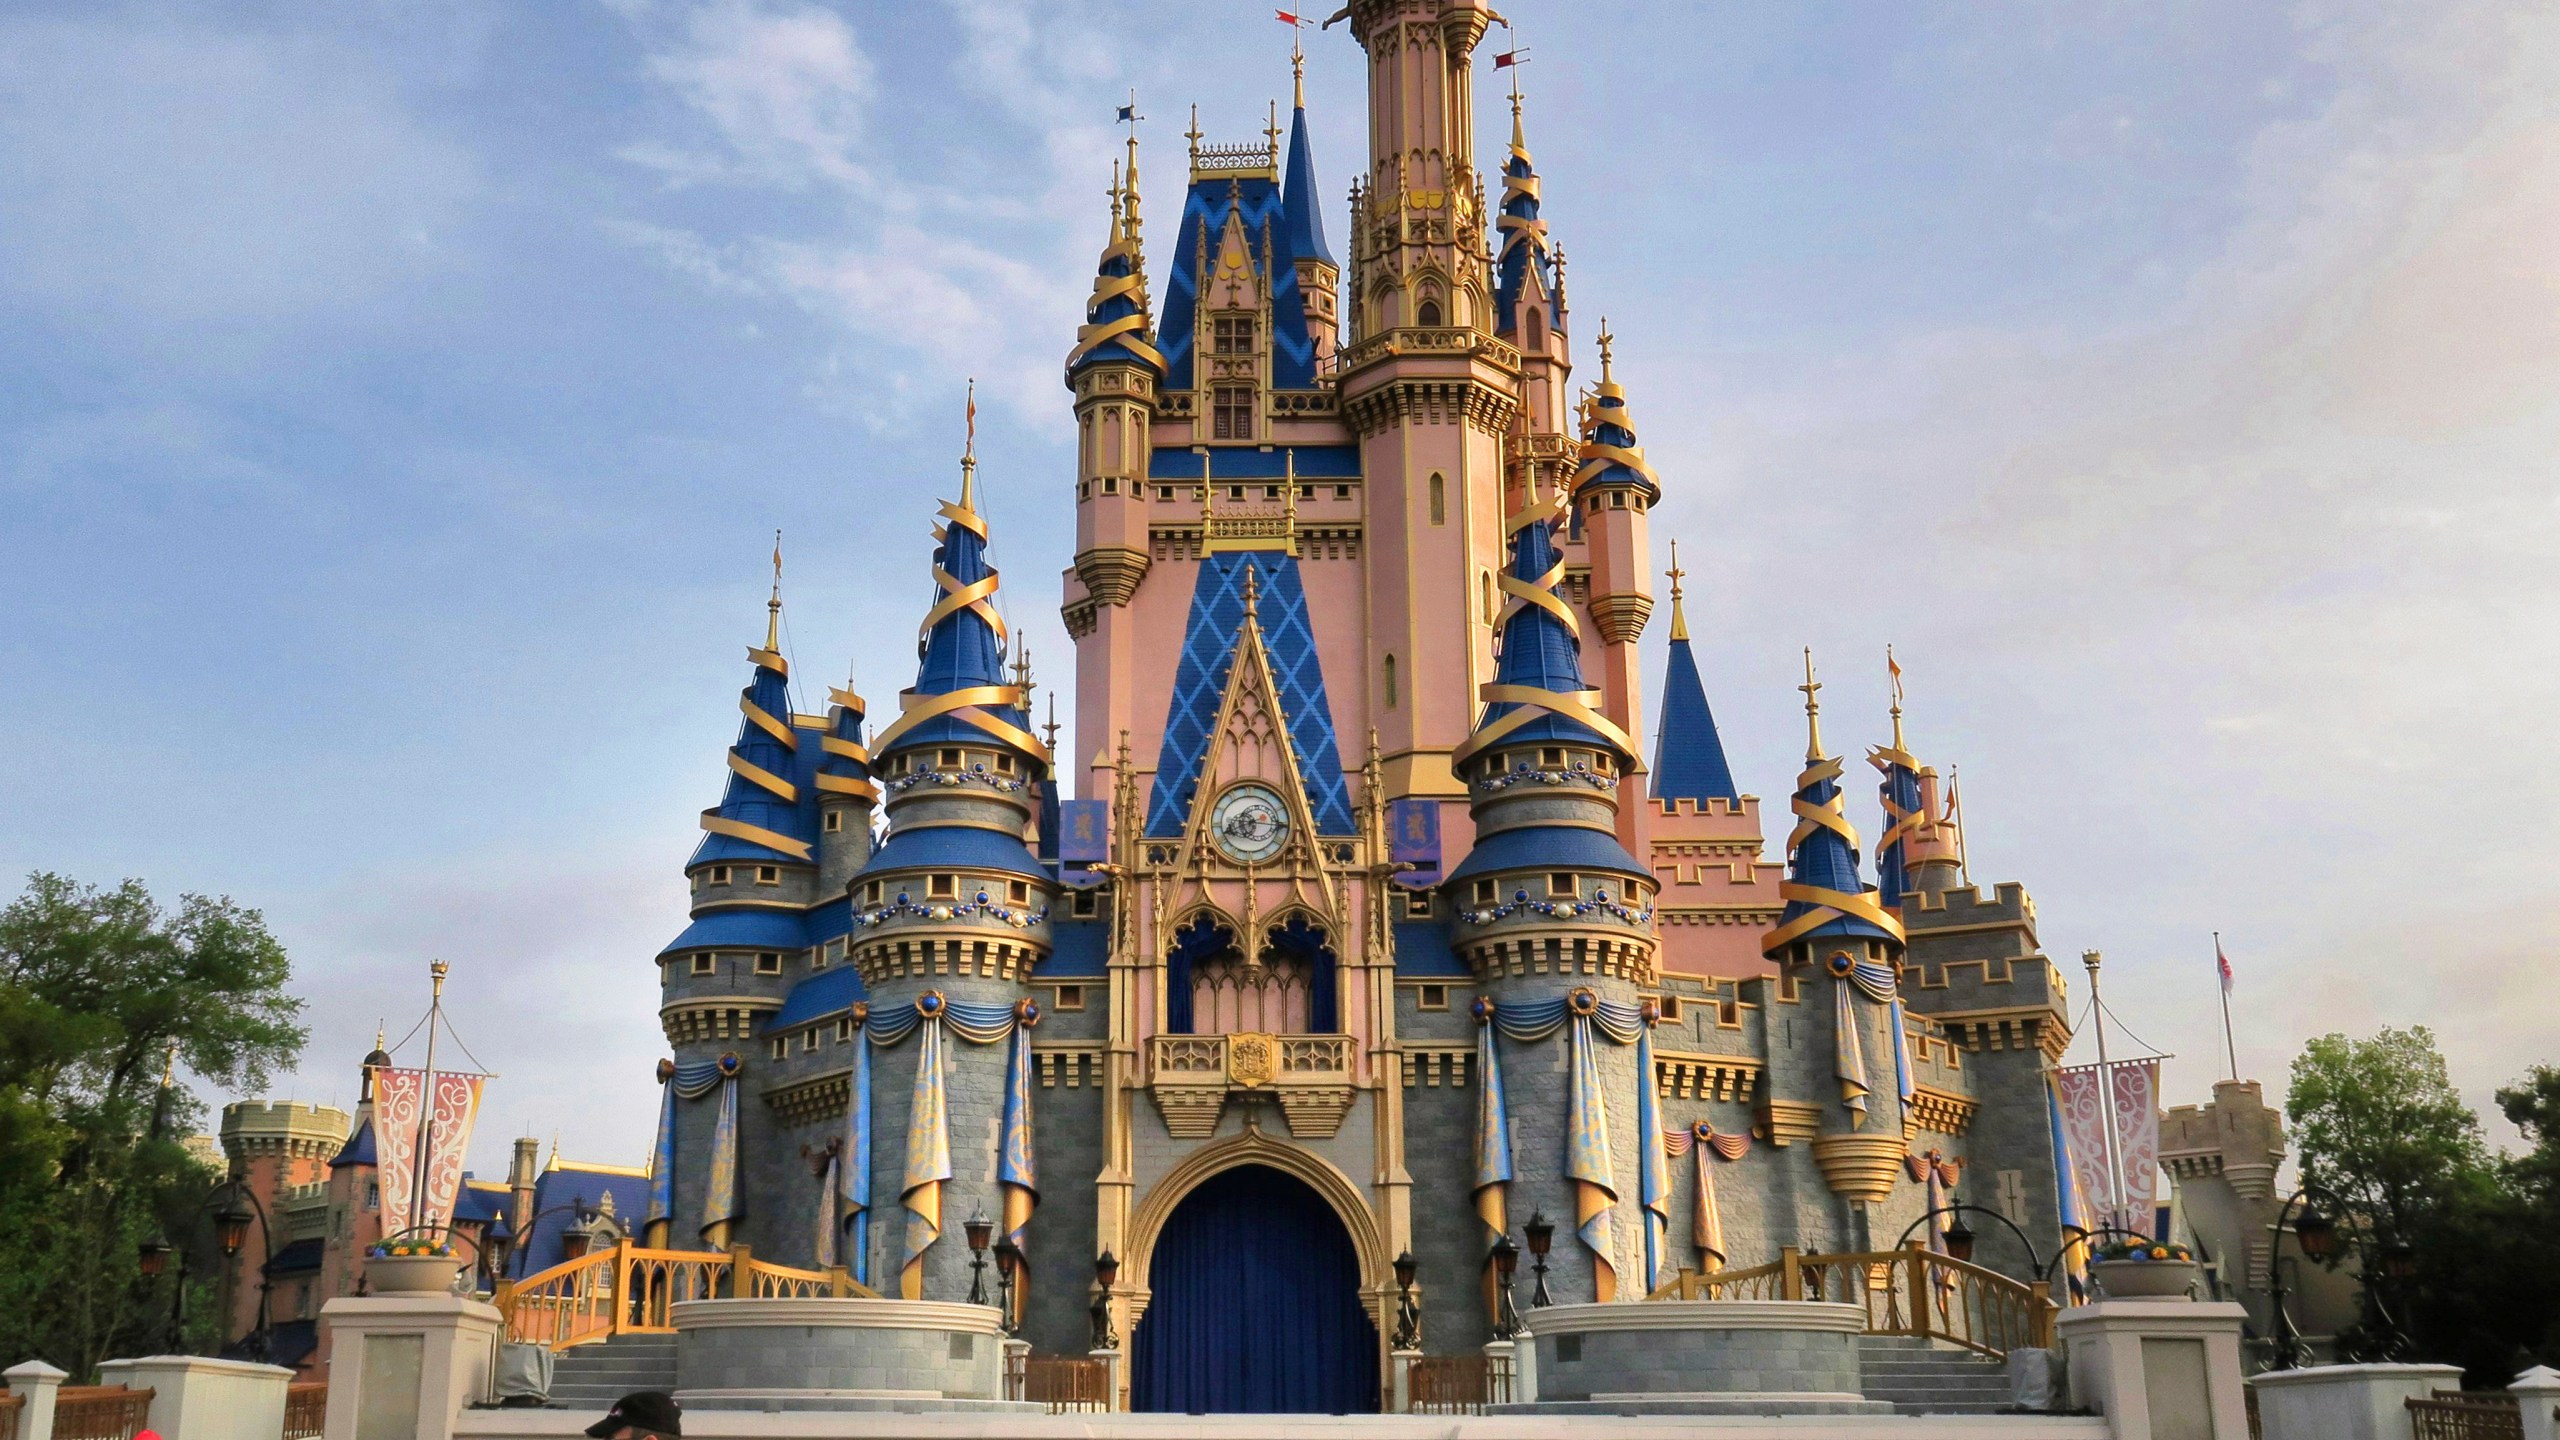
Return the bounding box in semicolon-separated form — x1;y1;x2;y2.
645;0;2074;1412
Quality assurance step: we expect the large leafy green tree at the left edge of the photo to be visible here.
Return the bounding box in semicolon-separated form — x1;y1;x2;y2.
0;874;305;1376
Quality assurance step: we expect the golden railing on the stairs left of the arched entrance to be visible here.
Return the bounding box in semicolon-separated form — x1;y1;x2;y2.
497;1240;881;1350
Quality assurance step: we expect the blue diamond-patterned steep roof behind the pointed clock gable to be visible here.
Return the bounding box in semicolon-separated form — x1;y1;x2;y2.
1147;551;1354;835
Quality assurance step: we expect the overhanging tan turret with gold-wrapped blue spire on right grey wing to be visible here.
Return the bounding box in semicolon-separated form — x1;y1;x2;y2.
1761;651;1907;1219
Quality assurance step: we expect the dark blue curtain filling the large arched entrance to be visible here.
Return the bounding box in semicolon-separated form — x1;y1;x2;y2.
1129;1166;1377;1414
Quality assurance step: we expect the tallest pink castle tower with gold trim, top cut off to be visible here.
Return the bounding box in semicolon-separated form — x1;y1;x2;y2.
1339;0;1521;799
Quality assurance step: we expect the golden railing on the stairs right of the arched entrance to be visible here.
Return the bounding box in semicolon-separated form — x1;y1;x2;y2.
1646;1245;2056;1355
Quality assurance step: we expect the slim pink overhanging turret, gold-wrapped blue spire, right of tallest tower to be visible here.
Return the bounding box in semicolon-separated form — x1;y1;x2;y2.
1574;325;1661;851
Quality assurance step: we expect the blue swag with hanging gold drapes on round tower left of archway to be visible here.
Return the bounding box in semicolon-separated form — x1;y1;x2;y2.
858;989;1039;1299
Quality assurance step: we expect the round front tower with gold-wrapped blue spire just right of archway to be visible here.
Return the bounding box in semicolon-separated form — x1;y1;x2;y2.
1446;471;1659;1302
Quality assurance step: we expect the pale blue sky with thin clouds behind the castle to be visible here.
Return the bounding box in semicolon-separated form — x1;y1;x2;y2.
0;0;2560;1163
